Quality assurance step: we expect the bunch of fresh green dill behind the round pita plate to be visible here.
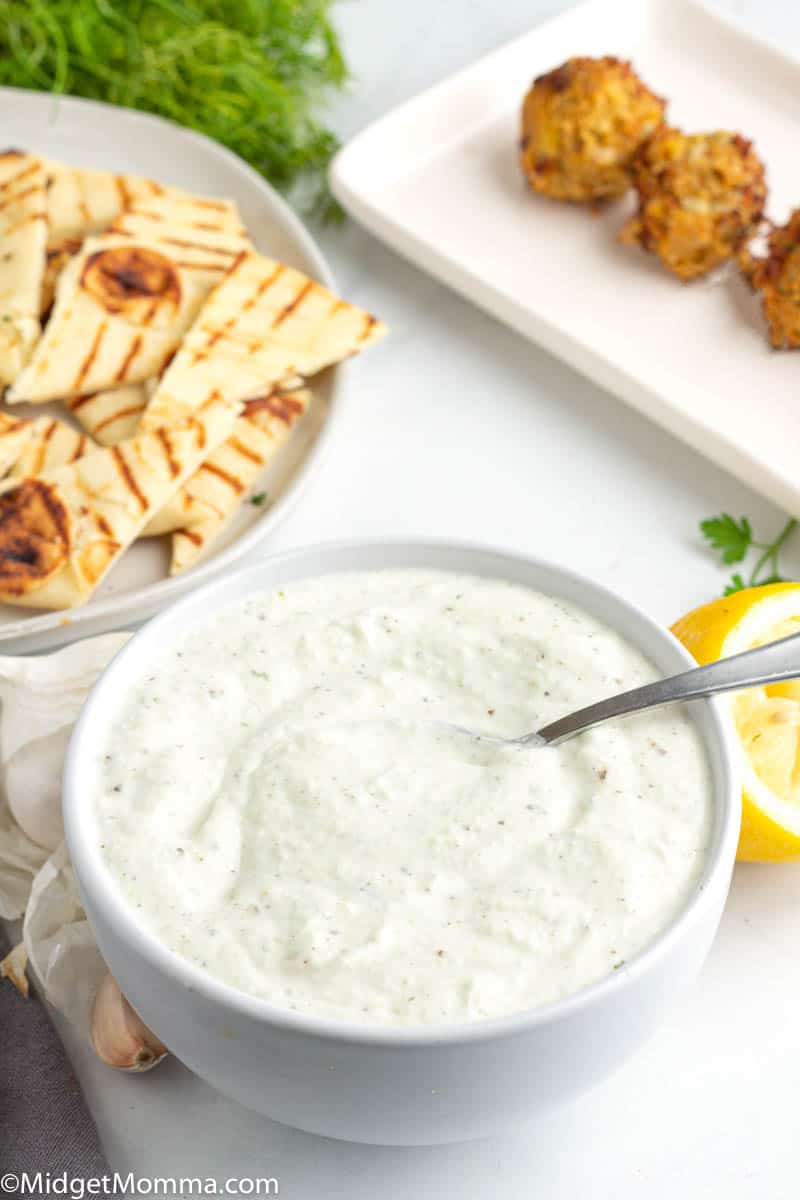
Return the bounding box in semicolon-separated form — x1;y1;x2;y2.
0;0;348;214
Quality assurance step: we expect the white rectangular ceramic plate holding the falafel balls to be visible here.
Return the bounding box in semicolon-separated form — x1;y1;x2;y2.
331;0;800;516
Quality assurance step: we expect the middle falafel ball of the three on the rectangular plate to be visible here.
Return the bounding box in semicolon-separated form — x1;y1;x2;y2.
620;126;766;281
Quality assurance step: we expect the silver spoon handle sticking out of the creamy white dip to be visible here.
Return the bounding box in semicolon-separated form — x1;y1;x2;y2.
534;634;800;745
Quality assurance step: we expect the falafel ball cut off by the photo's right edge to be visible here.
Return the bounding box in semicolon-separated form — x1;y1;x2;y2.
739;209;800;350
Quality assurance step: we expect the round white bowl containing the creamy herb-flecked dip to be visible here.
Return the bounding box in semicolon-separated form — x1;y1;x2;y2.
64;541;740;1145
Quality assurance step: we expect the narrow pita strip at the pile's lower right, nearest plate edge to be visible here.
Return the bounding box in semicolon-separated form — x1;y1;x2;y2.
145;389;311;556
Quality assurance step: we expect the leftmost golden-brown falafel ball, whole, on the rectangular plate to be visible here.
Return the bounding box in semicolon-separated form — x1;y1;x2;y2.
519;58;666;200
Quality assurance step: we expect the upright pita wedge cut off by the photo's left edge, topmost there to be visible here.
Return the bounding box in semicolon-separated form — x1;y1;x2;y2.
0;150;47;384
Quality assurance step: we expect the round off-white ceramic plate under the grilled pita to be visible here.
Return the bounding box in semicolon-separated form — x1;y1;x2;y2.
0;88;343;652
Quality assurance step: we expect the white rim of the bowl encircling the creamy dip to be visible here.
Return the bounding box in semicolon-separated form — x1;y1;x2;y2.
62;538;740;1048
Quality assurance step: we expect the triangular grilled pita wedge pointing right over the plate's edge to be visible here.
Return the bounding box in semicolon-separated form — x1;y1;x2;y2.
142;252;386;428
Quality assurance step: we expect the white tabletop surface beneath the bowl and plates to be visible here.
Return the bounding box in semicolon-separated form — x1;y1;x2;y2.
51;0;800;1200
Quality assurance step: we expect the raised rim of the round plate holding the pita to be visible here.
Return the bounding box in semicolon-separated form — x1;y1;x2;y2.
0;86;349;653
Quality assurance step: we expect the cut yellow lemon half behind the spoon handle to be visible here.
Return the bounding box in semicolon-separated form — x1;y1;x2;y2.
672;583;800;863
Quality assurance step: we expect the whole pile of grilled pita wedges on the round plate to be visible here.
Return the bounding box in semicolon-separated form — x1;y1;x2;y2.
0;151;385;608
